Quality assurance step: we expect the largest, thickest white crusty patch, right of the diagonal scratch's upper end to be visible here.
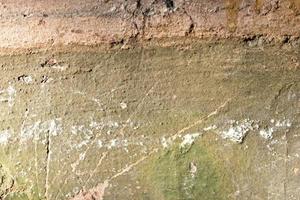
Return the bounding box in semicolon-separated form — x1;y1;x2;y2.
221;119;256;143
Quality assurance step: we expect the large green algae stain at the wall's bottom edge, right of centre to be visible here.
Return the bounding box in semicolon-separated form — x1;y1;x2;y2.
143;141;232;200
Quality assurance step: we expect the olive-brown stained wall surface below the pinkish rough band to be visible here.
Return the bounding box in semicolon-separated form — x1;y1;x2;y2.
0;40;300;200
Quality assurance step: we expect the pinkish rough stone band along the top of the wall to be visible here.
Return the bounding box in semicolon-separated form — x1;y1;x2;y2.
0;0;300;49
